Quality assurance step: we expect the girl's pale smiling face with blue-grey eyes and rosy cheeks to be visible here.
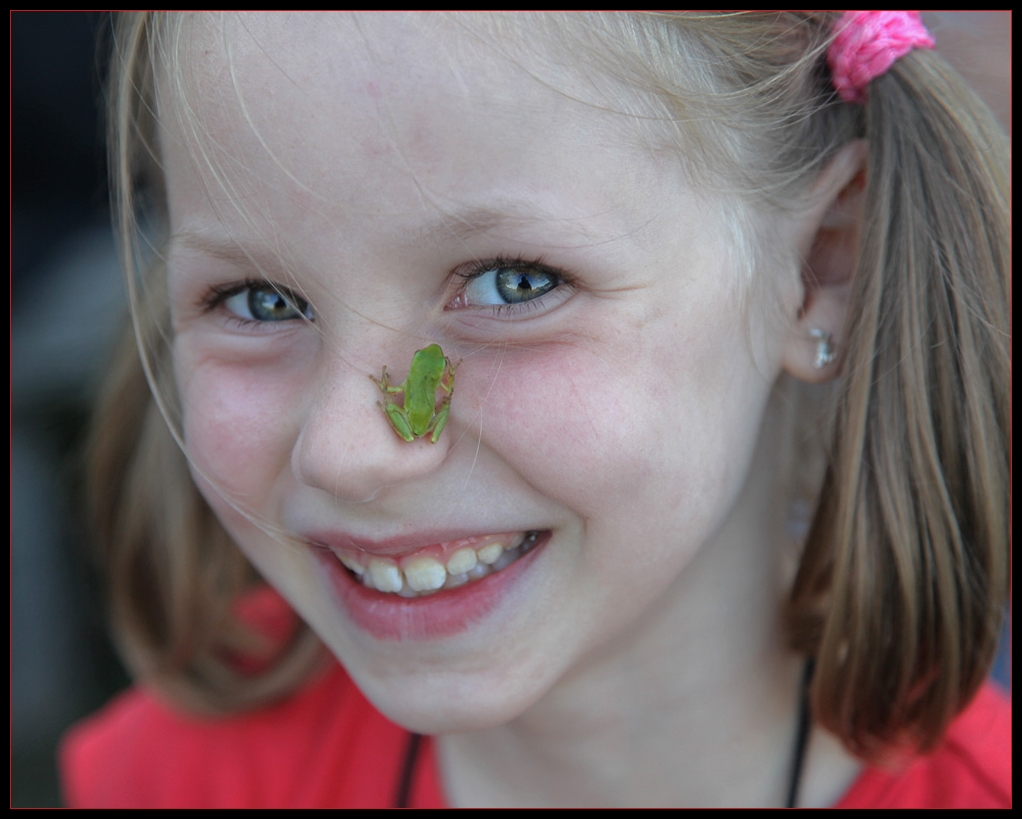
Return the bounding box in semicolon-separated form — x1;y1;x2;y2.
159;14;795;732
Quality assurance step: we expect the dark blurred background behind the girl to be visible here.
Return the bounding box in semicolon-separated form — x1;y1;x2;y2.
10;12;1011;808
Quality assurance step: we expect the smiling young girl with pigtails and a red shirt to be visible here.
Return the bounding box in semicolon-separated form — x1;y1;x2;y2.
62;12;1011;807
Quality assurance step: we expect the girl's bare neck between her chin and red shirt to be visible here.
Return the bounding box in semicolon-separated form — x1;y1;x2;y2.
439;625;799;807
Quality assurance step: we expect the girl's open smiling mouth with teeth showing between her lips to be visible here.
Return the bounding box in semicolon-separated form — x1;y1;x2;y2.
339;531;545;597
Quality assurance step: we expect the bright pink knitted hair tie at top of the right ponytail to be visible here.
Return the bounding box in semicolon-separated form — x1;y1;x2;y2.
827;11;934;103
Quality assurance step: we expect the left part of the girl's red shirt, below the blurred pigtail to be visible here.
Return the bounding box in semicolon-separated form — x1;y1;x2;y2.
60;664;445;808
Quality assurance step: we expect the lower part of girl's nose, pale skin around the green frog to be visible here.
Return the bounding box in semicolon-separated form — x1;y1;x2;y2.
291;345;454;502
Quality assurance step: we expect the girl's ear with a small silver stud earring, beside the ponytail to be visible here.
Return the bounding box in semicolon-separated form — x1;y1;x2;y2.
783;139;867;383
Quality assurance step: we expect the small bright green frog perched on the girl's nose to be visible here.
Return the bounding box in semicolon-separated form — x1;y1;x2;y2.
369;345;458;444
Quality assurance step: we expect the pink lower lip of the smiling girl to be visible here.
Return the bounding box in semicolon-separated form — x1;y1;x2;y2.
313;530;552;641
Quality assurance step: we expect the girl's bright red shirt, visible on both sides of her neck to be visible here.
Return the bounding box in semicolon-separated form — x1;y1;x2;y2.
60;665;1012;808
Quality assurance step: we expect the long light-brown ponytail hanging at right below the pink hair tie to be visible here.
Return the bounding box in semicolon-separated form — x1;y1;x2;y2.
790;46;1011;756
